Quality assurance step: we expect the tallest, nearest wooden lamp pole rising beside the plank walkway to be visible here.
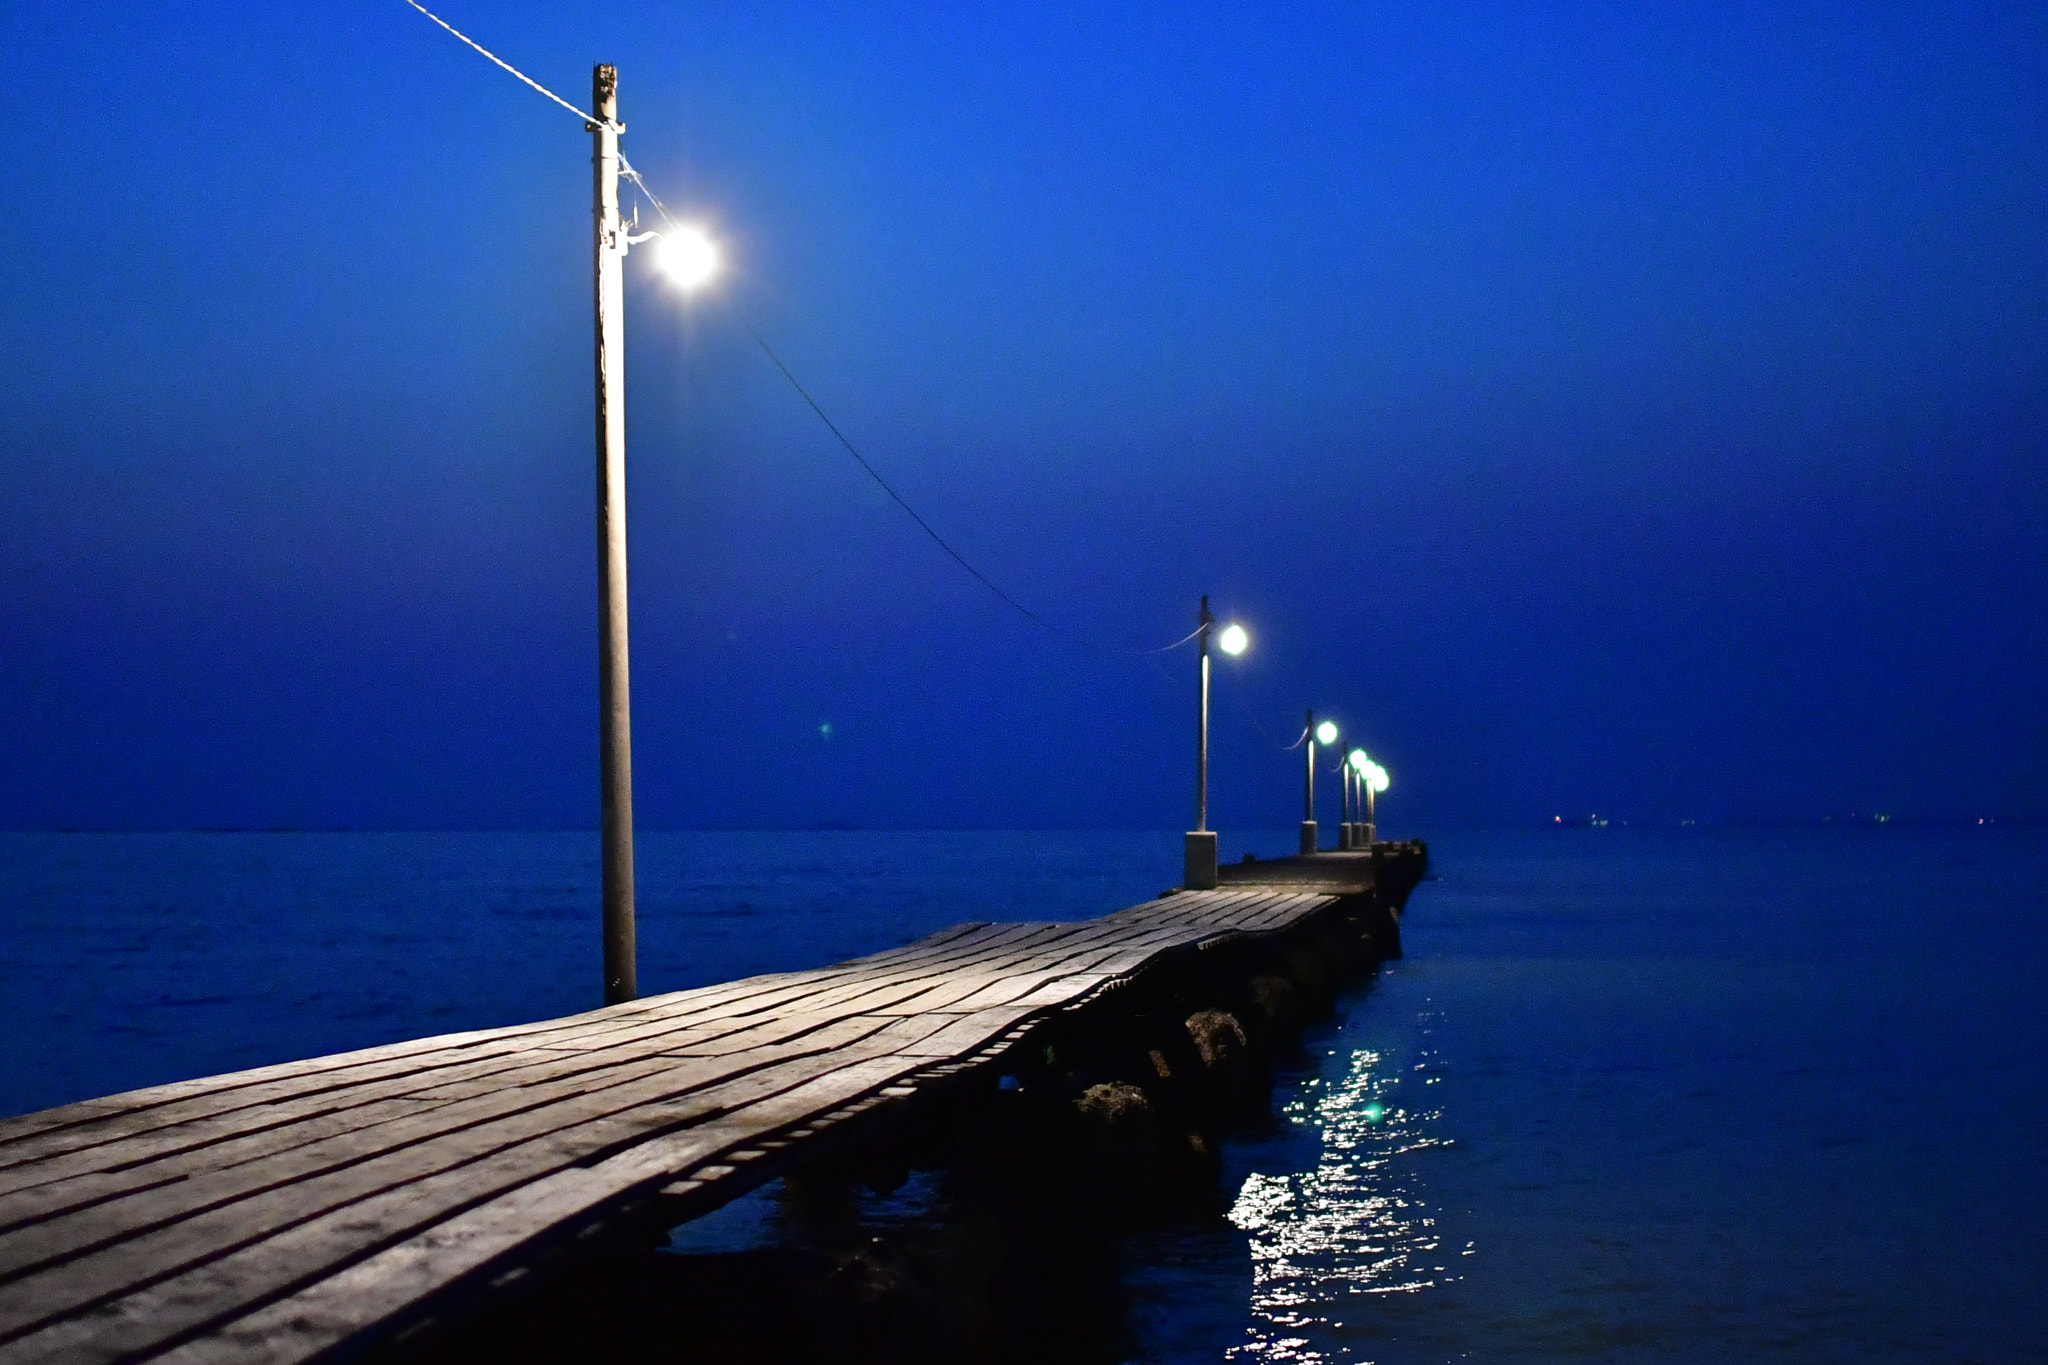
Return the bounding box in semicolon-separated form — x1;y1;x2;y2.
586;65;639;1005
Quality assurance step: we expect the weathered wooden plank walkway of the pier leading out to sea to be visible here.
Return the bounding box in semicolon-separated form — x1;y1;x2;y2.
0;845;1425;1365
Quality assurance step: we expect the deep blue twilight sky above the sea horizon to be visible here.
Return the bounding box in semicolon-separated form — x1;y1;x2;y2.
0;0;2048;833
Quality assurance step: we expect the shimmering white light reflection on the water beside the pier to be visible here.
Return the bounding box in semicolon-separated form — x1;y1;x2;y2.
1227;1015;1470;1361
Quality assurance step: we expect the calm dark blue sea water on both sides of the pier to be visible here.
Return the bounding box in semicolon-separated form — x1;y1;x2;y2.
0;827;2048;1363
